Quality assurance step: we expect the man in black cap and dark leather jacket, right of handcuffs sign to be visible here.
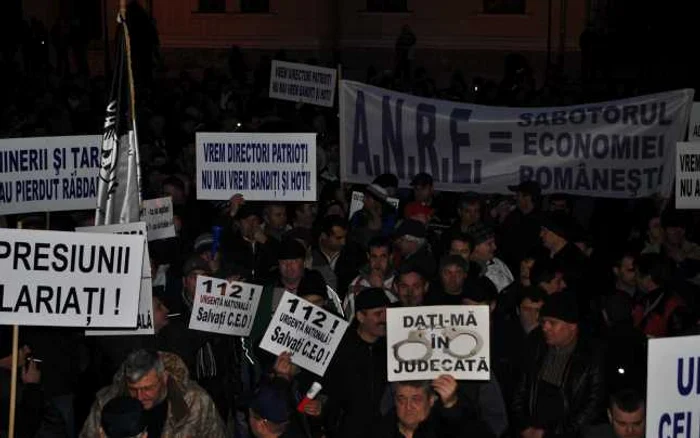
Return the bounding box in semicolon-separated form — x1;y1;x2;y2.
513;292;605;438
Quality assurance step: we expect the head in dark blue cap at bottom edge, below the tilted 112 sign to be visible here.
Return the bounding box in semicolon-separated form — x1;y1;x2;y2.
248;384;290;438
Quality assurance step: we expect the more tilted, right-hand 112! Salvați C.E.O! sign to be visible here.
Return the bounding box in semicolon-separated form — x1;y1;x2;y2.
260;291;348;376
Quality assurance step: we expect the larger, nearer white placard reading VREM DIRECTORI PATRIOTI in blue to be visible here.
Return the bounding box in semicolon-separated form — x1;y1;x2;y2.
196;132;316;202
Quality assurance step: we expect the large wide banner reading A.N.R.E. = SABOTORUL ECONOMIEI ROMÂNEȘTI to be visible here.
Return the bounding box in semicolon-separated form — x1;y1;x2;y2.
340;81;693;198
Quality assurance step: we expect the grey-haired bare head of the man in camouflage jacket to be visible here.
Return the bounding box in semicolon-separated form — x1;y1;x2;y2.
124;350;168;411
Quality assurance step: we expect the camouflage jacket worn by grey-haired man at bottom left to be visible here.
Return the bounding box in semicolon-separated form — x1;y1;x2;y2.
80;352;226;438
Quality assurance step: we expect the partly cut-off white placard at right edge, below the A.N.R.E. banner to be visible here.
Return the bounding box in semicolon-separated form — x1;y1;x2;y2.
676;141;700;209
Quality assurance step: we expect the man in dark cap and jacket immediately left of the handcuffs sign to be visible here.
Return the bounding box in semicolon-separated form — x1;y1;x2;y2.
324;288;389;438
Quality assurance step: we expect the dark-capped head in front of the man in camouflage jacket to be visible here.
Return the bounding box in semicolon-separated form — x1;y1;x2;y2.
100;396;148;438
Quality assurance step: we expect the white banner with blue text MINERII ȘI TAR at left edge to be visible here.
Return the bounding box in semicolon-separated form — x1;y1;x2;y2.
0;135;102;214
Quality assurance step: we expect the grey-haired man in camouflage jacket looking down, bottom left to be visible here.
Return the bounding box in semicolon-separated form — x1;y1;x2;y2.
80;350;226;438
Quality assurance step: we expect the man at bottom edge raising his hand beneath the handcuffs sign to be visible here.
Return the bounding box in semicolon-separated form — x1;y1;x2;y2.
373;375;492;438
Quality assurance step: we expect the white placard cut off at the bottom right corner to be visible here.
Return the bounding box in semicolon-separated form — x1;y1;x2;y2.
646;336;700;438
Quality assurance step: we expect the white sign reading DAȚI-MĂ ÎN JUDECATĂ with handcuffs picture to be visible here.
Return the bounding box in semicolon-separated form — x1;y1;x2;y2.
386;306;491;382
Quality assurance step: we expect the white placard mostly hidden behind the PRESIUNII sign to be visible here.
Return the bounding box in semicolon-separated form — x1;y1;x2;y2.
76;222;155;336
